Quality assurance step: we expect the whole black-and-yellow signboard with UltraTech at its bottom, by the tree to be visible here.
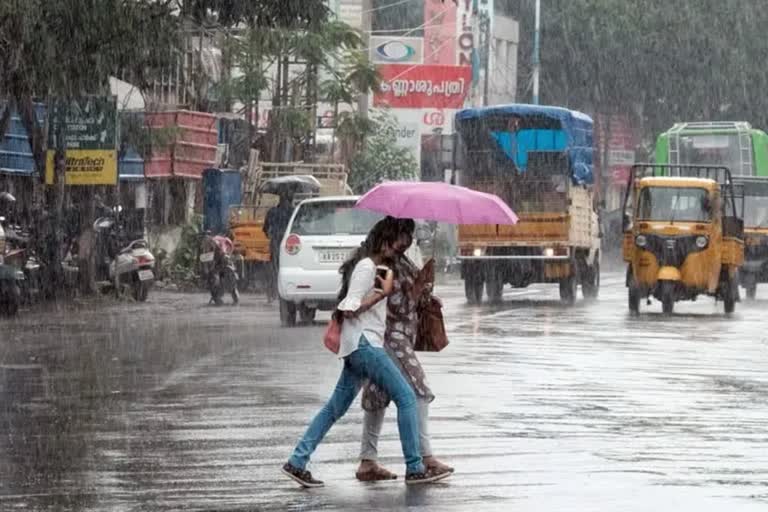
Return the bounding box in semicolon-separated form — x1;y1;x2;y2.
45;96;117;185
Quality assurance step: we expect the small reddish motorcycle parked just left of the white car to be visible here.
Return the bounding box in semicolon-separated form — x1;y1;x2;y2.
199;234;240;306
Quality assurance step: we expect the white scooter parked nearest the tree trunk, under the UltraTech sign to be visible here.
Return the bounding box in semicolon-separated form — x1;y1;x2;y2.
93;216;155;302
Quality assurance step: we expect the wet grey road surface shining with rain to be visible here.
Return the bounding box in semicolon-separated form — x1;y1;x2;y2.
0;274;768;512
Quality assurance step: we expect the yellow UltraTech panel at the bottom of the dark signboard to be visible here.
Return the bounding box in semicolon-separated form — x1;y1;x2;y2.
45;149;117;185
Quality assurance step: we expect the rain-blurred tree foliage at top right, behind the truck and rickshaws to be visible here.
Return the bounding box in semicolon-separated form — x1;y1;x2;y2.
519;0;768;135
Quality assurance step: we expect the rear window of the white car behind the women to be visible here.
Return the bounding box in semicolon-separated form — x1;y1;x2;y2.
291;201;383;236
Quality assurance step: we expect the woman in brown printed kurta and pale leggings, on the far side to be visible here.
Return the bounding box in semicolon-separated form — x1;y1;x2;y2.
357;220;452;481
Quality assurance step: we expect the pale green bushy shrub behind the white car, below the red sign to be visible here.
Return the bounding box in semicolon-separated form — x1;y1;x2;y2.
349;110;419;193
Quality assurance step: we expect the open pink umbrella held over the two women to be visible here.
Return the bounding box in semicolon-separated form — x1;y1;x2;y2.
356;181;517;224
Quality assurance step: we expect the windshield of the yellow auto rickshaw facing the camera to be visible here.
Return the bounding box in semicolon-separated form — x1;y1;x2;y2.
637;187;711;222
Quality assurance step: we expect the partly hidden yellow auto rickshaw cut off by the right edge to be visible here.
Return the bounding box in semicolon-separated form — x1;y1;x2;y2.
734;176;768;300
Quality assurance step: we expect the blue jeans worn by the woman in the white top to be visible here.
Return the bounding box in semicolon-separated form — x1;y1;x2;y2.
288;337;424;474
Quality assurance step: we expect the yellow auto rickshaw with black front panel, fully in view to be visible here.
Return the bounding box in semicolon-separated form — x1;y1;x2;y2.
623;164;744;314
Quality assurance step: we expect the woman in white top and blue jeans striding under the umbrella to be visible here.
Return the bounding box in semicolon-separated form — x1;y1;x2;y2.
282;218;451;487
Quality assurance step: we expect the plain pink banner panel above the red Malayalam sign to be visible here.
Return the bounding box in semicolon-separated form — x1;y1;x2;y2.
424;0;457;66
